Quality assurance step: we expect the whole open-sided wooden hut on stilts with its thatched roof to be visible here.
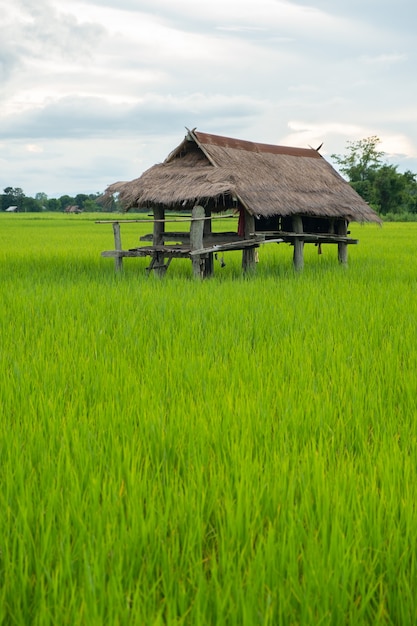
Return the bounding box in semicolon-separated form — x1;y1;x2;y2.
102;129;381;276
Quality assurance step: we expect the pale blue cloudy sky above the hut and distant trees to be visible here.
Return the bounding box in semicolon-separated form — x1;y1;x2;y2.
0;0;417;197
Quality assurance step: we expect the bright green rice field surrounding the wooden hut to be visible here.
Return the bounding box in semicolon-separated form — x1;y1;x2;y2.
0;214;417;626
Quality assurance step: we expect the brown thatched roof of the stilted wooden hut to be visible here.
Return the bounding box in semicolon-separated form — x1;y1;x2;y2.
106;130;381;222
